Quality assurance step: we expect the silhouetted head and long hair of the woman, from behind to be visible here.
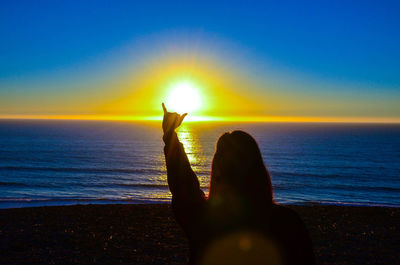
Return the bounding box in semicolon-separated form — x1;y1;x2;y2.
209;131;273;205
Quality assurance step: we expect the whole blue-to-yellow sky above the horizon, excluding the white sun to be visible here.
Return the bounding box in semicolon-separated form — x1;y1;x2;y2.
0;0;400;121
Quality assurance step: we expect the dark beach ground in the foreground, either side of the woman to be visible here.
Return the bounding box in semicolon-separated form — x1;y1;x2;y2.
0;204;400;264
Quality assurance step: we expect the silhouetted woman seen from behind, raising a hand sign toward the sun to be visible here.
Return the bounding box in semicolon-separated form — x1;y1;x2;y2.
162;104;315;265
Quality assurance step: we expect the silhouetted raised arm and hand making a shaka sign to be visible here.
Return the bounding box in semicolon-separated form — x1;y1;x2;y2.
162;103;205;226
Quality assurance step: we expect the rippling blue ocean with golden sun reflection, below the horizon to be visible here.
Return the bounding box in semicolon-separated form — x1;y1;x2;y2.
0;120;400;208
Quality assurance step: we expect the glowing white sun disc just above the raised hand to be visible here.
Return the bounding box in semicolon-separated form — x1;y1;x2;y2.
165;82;202;113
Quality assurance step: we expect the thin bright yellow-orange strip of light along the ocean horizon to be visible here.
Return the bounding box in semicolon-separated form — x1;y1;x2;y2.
0;115;400;124
